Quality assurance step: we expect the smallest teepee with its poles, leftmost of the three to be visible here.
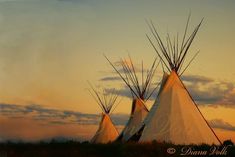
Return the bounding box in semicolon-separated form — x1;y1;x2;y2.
90;85;118;143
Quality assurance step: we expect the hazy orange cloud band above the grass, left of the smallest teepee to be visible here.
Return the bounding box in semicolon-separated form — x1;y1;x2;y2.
0;116;97;141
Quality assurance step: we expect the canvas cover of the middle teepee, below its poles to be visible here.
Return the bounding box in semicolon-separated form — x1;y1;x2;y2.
121;99;149;141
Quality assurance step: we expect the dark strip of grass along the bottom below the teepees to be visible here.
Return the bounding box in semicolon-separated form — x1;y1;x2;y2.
0;141;235;157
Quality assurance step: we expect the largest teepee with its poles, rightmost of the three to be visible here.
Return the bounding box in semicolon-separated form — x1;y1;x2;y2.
139;18;221;145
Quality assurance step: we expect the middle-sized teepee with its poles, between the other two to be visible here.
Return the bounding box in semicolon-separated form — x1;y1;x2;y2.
105;56;158;141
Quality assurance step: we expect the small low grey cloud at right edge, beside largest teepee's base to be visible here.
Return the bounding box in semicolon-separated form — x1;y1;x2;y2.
208;119;235;131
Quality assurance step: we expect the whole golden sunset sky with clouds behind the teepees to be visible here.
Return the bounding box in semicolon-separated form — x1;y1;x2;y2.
0;0;235;142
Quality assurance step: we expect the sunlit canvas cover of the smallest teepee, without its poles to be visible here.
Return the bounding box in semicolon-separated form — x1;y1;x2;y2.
91;113;118;143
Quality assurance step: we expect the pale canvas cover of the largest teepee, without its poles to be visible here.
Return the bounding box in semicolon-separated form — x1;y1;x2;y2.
139;71;220;144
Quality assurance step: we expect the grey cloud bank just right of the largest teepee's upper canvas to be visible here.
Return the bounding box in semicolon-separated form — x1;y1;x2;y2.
182;75;235;107
